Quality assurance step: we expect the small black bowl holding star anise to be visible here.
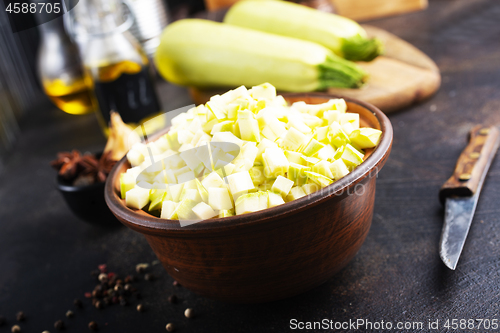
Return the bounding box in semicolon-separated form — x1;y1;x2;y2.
57;154;122;226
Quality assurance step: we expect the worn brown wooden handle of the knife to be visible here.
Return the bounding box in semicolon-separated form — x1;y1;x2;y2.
439;125;500;204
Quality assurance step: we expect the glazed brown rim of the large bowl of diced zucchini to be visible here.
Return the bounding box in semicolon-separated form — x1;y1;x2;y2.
104;93;393;235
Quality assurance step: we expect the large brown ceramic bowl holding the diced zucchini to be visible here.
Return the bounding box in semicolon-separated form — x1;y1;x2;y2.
105;93;392;303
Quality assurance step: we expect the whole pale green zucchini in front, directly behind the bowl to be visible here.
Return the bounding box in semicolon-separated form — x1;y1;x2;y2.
155;19;366;91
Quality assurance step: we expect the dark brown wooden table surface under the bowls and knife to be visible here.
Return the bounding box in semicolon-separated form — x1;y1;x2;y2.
0;0;500;333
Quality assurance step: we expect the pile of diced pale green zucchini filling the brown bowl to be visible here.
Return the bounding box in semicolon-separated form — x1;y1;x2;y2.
120;83;382;220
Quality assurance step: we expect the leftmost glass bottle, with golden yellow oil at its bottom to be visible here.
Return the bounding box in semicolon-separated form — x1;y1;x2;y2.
36;8;94;114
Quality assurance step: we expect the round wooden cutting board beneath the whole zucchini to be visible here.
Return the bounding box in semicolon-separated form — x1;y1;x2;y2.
190;25;441;113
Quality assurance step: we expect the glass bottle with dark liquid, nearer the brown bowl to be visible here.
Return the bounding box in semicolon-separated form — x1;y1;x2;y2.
75;0;164;134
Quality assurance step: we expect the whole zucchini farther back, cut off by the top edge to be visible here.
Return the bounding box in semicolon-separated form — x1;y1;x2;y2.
224;0;383;61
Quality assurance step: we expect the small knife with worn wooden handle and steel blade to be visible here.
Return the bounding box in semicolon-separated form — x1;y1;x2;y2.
439;125;500;270
